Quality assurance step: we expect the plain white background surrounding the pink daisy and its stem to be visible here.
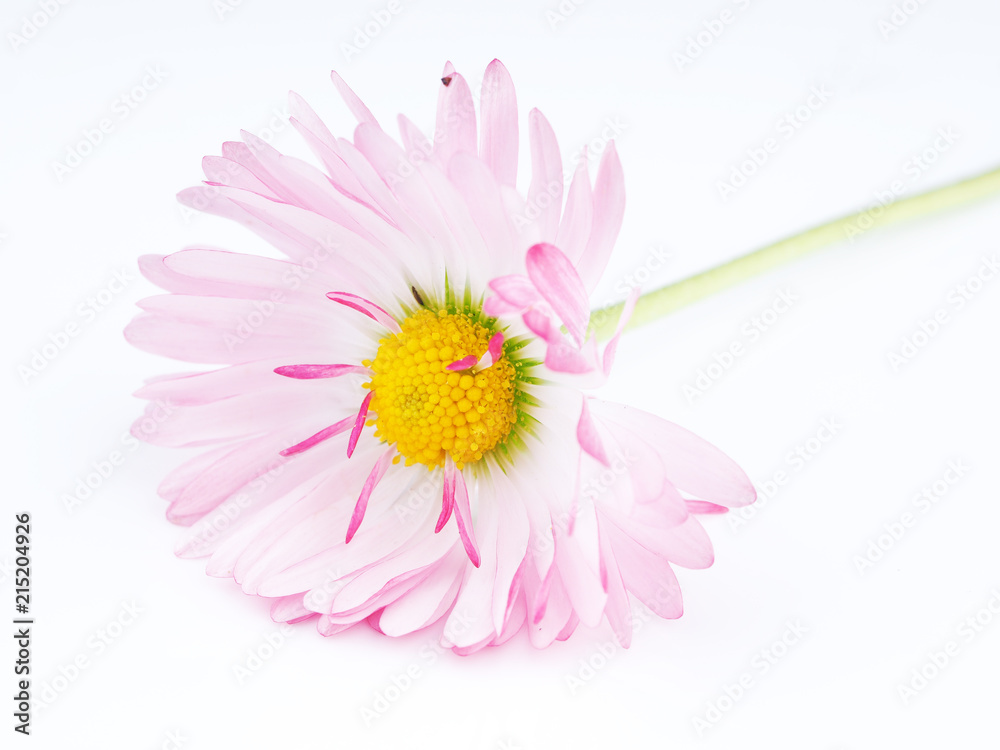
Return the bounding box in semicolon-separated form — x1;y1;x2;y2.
0;0;1000;750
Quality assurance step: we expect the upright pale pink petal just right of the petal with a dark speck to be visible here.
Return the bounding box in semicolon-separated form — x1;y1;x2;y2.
479;60;518;186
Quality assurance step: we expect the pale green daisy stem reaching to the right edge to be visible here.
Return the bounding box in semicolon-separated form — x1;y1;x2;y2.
591;168;1000;339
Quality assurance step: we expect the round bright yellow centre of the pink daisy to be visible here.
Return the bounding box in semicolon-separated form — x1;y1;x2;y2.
364;309;517;468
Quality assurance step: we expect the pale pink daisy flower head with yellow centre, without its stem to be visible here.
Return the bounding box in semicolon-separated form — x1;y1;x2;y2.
126;60;755;654
